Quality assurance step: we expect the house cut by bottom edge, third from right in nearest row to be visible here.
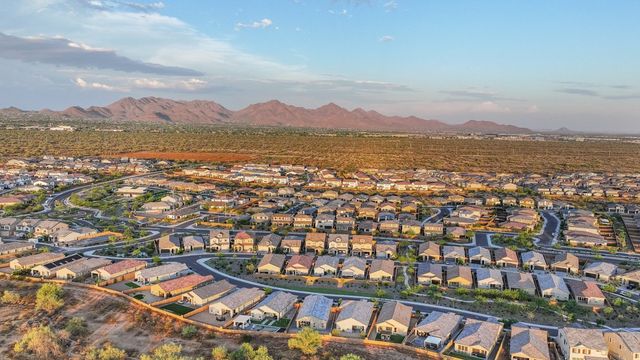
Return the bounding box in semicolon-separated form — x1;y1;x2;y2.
509;324;551;360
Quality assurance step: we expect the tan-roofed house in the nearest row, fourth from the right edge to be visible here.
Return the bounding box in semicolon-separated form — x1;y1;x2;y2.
453;318;503;359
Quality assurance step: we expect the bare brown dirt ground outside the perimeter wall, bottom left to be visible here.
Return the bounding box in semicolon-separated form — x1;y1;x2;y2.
0;280;422;360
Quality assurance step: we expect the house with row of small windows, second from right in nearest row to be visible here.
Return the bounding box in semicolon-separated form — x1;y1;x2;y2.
557;327;609;360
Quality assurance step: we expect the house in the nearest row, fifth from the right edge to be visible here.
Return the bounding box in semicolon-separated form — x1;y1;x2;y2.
413;311;462;350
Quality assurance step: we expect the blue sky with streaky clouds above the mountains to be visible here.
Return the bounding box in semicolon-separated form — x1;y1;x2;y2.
0;0;640;134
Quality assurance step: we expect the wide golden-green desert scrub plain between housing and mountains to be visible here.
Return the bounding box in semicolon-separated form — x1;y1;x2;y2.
0;128;640;173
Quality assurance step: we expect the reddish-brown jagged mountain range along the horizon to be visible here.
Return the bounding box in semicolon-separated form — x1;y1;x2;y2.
0;97;532;134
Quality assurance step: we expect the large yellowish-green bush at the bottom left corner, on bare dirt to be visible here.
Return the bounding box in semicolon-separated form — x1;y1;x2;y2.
13;325;62;359
